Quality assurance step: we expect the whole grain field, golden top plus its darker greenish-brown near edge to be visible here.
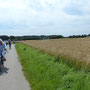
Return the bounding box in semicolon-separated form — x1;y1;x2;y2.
22;38;90;71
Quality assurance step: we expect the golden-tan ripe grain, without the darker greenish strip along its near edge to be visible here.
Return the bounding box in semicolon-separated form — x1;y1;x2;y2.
23;38;90;63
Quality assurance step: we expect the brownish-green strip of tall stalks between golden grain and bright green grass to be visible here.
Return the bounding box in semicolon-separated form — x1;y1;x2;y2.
20;42;90;72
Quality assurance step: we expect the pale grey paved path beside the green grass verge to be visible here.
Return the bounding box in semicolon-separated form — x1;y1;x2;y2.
0;45;30;90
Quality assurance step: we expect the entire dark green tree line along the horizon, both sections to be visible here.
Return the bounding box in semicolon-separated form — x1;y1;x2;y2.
0;34;90;41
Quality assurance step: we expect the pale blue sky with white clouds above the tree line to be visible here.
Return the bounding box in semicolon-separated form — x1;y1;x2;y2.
0;0;90;36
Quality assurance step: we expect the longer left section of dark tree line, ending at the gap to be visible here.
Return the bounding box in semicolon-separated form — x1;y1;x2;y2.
0;35;63;41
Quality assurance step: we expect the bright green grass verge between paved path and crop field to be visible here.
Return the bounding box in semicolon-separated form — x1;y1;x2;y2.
16;43;90;90
